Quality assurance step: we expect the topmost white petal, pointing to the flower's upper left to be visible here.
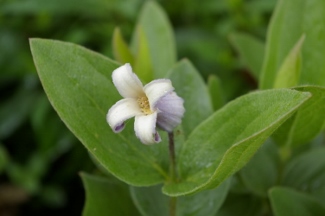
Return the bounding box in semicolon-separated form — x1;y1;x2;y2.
112;63;144;98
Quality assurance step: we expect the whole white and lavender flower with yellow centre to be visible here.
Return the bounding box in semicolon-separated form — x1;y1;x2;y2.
106;64;185;144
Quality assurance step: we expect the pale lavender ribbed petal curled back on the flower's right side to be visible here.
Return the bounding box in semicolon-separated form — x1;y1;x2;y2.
156;92;185;132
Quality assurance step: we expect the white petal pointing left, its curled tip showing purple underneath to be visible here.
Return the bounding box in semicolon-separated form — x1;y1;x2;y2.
106;98;142;133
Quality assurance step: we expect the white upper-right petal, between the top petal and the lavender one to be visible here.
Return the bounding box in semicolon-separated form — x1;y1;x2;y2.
144;79;174;109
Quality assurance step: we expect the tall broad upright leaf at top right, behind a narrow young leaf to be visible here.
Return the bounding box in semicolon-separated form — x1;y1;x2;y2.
260;0;325;89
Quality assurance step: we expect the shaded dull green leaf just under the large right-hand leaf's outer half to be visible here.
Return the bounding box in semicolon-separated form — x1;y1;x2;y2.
239;140;279;197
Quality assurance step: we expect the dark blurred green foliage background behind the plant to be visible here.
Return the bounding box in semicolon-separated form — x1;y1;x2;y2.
0;0;276;216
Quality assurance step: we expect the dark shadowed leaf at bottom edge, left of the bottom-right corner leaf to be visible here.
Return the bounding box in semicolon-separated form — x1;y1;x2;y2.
216;193;262;216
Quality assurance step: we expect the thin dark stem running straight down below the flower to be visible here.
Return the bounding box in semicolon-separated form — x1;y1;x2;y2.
168;132;177;216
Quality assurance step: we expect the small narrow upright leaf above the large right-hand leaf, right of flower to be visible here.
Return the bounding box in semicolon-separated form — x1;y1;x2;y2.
208;75;225;110
